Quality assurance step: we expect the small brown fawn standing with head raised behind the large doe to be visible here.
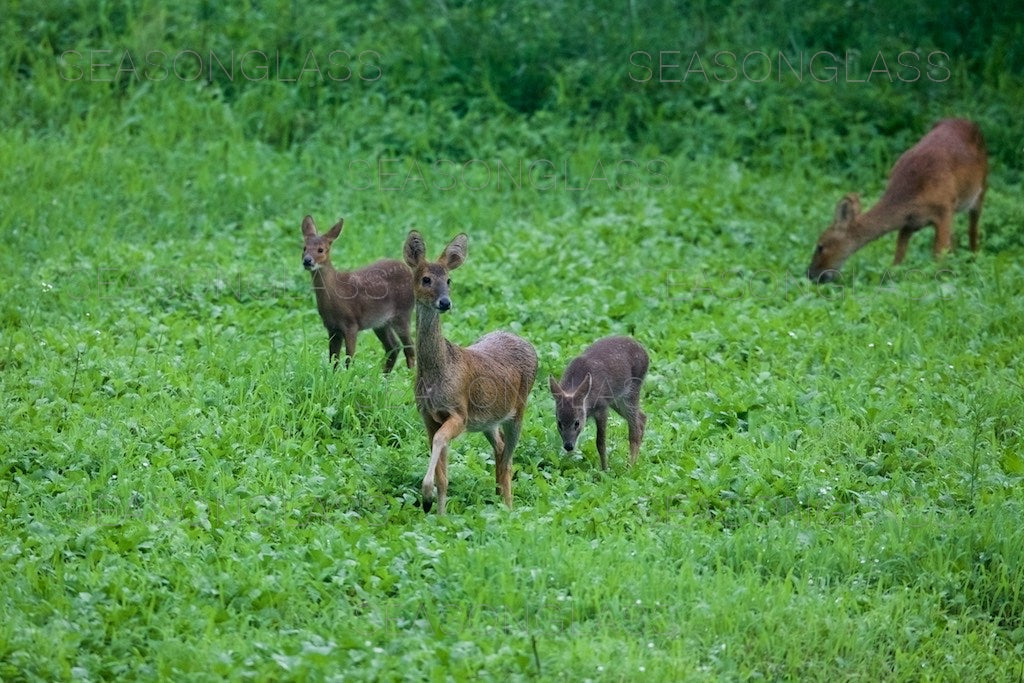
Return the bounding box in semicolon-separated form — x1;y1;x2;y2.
302;216;415;373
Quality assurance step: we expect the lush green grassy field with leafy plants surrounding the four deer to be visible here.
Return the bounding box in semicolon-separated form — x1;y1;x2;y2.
0;2;1024;681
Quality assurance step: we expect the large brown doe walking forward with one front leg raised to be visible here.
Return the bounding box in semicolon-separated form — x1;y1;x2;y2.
404;230;537;514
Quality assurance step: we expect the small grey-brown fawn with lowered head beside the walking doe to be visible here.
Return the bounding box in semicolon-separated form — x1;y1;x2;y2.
548;337;649;470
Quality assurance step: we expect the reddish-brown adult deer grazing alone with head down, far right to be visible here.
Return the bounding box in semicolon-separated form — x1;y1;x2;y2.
807;119;988;282
